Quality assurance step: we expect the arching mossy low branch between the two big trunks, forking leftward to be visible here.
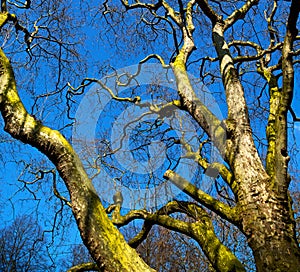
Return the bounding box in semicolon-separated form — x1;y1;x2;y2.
108;198;245;271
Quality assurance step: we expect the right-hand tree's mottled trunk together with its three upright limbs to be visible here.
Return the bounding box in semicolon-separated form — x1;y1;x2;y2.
172;0;300;271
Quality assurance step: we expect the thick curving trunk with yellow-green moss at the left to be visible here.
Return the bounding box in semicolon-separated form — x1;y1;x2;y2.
0;49;154;272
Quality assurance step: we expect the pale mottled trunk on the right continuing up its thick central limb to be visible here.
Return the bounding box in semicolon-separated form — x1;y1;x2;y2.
213;19;300;272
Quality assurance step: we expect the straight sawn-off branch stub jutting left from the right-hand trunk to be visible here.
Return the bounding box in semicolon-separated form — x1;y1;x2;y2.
164;170;238;223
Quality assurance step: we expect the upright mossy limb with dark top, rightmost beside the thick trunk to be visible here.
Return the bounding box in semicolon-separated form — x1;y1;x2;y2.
262;1;300;190
